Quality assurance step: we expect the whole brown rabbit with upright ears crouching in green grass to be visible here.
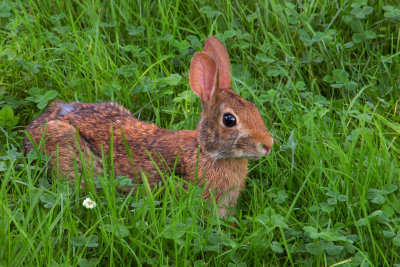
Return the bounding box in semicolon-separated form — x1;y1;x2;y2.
24;37;273;217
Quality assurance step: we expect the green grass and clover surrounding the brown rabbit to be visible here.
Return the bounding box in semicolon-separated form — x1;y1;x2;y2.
0;0;400;266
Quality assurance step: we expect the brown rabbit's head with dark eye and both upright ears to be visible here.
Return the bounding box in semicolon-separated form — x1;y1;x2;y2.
189;37;274;159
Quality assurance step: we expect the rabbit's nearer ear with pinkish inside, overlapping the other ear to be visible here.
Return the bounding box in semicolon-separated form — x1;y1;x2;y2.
189;52;218;104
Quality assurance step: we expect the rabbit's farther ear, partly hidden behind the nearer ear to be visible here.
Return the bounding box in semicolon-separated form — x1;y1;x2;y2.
203;36;232;90
